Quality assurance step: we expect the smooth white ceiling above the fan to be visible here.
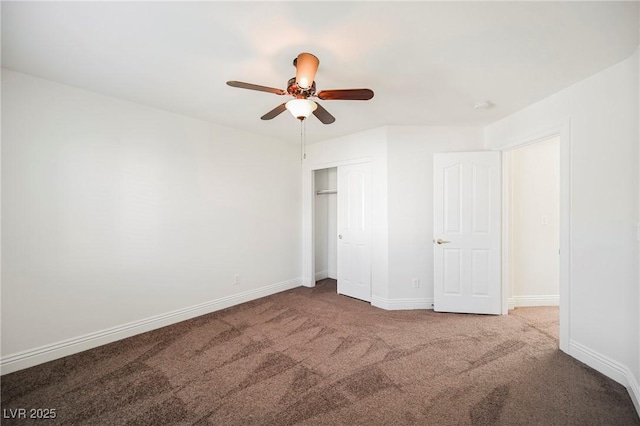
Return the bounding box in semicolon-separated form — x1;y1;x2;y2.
1;1;639;142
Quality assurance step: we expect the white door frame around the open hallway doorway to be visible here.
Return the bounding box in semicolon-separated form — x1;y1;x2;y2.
498;119;571;353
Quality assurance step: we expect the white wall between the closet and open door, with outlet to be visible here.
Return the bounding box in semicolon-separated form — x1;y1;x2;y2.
388;126;484;309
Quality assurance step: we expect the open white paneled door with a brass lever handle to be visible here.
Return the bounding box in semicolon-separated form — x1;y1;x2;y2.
433;151;502;314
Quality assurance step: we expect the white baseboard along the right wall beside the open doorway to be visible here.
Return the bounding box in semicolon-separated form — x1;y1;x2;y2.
569;340;640;414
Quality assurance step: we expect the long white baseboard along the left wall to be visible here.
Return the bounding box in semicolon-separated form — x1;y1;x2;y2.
0;278;301;374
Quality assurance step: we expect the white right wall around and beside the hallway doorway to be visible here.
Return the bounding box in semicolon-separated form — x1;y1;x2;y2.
485;51;640;397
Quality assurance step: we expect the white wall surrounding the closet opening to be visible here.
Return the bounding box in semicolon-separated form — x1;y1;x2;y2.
302;127;389;297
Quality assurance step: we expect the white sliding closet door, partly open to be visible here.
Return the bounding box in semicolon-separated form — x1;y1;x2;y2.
338;163;371;302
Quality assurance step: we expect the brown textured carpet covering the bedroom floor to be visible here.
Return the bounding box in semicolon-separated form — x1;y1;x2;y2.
1;280;640;425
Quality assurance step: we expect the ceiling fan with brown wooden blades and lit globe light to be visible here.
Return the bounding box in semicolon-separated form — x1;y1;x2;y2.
227;52;373;124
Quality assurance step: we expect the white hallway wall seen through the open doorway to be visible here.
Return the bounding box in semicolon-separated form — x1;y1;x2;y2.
508;137;560;306
